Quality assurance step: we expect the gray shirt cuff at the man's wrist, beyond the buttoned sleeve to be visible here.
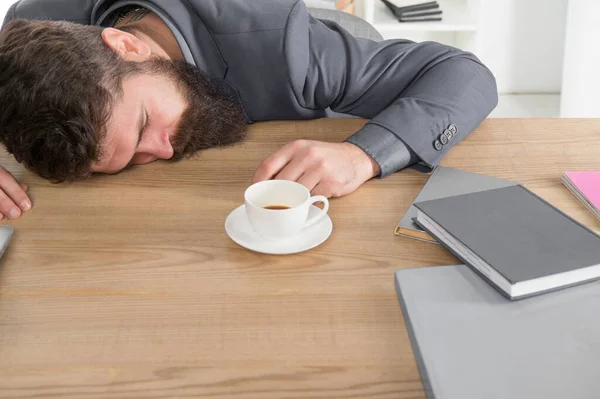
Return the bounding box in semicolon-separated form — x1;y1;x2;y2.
344;123;420;177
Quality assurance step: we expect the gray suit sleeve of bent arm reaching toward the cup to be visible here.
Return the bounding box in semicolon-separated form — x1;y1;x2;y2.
284;1;498;177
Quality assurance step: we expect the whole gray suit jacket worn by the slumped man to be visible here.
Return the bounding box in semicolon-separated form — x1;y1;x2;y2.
5;0;497;176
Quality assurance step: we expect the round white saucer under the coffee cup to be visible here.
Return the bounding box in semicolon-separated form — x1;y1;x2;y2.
225;205;333;255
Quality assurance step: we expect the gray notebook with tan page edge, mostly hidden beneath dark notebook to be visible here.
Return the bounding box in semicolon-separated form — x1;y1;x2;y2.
394;166;518;242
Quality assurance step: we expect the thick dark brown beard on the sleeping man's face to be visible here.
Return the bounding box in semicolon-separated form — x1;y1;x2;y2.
139;59;248;161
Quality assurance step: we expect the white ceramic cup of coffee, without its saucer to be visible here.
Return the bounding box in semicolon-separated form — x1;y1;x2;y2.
244;180;329;240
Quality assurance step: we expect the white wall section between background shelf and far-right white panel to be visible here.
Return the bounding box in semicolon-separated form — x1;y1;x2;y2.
477;0;568;93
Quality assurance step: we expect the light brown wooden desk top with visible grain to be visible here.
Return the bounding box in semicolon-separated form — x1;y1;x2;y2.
0;119;600;399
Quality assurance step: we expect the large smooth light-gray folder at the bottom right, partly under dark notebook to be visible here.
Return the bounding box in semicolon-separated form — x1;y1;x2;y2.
396;265;600;399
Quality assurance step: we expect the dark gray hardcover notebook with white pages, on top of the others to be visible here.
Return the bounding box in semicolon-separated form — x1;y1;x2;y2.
415;185;600;299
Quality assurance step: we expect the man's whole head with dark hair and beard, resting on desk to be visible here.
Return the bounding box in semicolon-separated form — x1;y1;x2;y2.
0;20;246;182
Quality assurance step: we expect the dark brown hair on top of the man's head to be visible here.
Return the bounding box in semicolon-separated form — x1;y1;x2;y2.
0;19;135;183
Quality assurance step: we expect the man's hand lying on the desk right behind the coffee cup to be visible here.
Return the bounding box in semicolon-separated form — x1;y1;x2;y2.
252;140;380;198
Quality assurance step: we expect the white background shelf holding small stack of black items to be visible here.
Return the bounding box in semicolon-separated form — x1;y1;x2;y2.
365;0;477;32
